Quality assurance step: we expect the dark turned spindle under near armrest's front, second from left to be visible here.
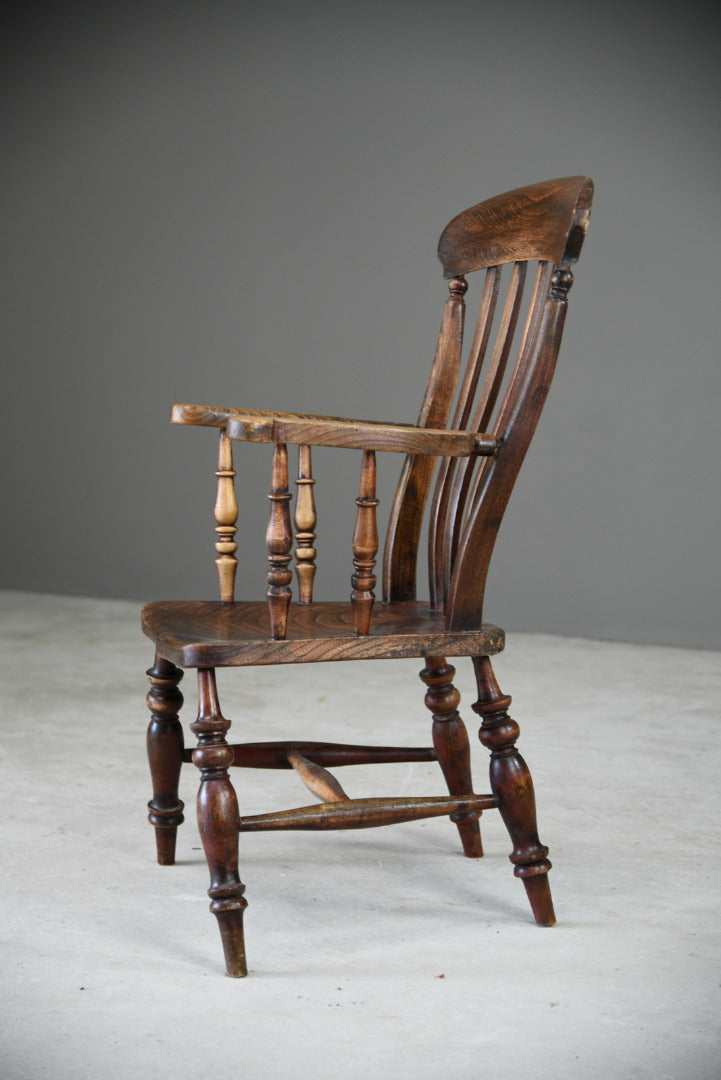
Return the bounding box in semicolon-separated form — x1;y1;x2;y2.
266;443;293;640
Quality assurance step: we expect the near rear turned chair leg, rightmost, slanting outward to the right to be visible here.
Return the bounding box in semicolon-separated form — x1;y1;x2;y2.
473;657;556;927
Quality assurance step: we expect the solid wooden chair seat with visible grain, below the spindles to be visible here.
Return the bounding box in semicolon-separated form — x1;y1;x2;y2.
142;600;505;667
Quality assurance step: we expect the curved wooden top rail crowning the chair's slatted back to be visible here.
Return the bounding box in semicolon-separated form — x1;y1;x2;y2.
438;176;594;278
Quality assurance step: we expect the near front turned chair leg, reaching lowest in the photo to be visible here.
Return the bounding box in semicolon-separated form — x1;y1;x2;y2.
191;669;248;978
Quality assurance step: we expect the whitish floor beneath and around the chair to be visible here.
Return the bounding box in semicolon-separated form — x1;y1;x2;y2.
0;593;721;1080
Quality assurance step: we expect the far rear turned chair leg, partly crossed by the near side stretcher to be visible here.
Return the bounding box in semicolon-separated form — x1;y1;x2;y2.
420;657;484;859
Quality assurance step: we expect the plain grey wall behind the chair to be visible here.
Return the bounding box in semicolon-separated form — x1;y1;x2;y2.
0;0;721;648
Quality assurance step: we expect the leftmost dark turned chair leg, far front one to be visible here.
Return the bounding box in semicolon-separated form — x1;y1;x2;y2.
146;656;183;866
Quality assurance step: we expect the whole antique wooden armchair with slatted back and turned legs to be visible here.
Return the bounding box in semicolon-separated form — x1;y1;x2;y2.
142;176;593;976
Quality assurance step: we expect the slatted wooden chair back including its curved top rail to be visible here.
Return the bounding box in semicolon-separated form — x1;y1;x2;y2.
383;176;594;630
